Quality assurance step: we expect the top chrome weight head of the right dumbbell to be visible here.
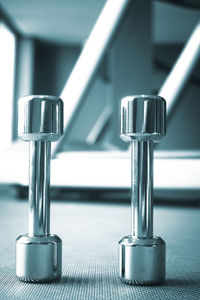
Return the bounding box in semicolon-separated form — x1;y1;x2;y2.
120;95;166;142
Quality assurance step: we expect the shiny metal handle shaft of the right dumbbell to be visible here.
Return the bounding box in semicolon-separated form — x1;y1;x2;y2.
131;141;153;238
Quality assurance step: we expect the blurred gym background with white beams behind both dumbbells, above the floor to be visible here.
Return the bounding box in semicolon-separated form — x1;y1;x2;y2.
0;0;200;201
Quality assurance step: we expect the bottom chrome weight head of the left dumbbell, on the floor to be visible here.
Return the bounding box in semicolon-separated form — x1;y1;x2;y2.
16;235;62;282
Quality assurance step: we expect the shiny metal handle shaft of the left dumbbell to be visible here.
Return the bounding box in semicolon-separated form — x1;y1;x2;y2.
29;141;51;237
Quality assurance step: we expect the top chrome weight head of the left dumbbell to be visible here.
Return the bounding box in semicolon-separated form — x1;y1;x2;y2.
18;95;63;142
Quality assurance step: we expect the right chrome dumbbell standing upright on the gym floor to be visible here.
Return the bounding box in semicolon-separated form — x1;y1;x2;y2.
119;95;166;285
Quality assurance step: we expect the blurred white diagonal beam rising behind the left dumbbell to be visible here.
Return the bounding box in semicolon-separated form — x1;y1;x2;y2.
52;0;131;156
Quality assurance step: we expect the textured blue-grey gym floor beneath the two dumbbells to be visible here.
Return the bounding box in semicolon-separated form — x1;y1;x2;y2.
0;196;200;300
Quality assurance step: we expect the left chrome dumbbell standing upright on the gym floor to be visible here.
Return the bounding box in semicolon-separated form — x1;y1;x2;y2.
16;96;63;282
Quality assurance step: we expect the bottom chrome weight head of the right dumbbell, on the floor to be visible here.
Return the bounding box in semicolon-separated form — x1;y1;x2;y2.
119;236;165;285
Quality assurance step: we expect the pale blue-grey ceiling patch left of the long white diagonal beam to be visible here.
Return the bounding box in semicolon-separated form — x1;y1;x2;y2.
0;0;105;44
